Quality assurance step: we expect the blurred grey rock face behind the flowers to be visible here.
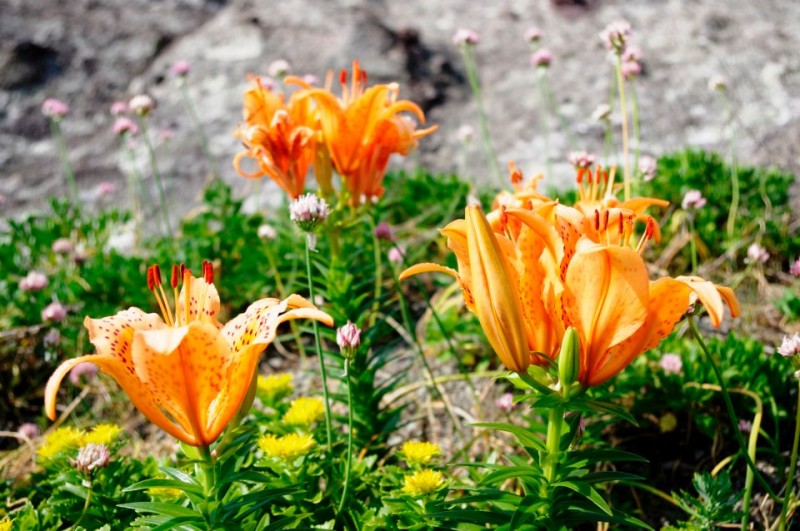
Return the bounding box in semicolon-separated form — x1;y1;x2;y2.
0;0;800;216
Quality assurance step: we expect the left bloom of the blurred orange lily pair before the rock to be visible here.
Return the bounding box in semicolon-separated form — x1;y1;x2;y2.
233;78;316;199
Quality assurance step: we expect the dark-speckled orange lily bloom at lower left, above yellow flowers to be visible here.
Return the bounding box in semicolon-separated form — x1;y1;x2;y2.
45;262;333;446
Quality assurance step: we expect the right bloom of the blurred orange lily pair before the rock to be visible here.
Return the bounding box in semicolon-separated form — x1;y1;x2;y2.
286;61;437;206
